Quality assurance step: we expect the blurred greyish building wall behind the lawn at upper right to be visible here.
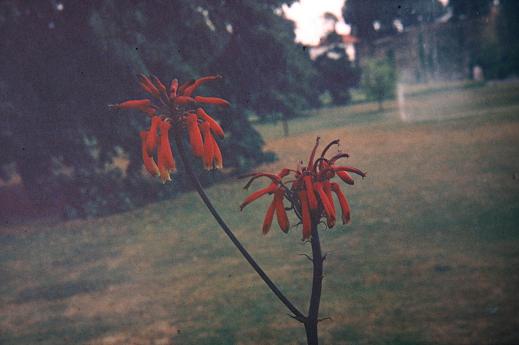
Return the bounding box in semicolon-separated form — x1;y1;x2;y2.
359;13;495;83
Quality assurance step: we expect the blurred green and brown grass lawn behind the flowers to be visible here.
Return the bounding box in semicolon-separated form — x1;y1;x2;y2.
0;83;519;345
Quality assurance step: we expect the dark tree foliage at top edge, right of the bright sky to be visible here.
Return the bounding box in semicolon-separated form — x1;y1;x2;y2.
343;0;445;42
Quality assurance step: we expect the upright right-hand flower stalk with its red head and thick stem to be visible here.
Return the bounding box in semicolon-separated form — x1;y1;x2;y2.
240;138;366;344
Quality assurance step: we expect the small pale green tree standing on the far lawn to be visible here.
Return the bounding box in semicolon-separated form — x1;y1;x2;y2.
361;58;396;111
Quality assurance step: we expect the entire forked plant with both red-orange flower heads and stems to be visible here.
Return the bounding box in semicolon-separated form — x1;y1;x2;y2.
110;75;365;345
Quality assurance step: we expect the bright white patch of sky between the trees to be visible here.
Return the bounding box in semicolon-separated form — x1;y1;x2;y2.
283;0;349;45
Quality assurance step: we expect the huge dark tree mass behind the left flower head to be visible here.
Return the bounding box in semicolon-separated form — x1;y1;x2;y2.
0;0;315;215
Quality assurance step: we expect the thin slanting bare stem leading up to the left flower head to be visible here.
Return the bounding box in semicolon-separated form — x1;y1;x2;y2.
174;132;306;327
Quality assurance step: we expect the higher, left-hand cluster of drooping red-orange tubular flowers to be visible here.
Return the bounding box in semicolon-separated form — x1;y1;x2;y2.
110;74;229;183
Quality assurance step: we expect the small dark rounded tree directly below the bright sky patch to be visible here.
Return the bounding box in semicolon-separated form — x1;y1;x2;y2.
314;32;360;105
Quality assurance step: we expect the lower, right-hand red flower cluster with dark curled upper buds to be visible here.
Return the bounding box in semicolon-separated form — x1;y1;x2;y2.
240;138;366;240
